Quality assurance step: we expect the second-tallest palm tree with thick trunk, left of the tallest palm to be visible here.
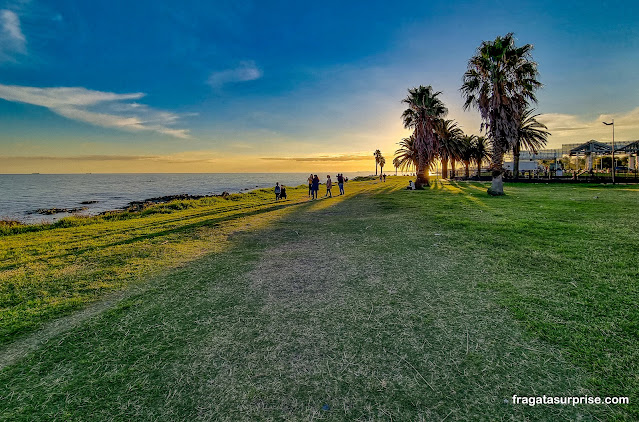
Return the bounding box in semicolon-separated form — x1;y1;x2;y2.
402;85;448;189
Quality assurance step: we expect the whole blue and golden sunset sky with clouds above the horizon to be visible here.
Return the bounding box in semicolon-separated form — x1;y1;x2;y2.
0;0;639;173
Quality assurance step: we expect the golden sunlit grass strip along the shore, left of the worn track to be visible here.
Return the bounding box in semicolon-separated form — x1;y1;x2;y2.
0;188;344;345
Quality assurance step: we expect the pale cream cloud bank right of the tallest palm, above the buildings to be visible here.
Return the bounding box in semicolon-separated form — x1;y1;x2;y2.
538;107;639;148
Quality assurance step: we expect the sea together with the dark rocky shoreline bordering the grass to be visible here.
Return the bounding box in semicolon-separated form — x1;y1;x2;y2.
0;173;378;225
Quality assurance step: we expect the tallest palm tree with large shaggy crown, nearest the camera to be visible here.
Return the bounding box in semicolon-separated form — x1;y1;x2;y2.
461;33;541;195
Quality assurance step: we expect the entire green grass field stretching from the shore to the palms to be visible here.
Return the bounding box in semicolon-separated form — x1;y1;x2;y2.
0;177;639;421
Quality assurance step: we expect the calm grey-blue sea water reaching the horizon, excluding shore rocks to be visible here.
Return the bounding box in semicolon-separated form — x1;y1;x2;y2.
0;173;370;223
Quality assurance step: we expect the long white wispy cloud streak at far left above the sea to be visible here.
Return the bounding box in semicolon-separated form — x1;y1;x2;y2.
0;84;190;139
